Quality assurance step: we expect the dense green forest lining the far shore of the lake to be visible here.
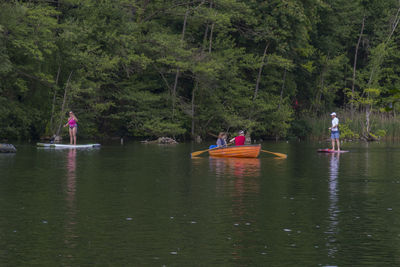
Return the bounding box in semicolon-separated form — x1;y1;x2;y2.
0;0;400;140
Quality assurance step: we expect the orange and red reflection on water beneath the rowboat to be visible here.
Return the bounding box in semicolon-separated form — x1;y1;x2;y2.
210;157;260;177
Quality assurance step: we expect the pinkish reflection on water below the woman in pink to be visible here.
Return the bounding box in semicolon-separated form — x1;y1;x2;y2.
64;149;77;258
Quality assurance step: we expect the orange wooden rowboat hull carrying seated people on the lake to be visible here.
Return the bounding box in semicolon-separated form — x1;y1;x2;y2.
208;145;261;158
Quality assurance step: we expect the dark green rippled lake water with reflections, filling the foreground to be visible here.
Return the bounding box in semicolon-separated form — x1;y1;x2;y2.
0;142;400;266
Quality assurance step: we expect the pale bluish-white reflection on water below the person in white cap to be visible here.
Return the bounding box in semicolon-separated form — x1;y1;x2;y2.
326;153;340;257
